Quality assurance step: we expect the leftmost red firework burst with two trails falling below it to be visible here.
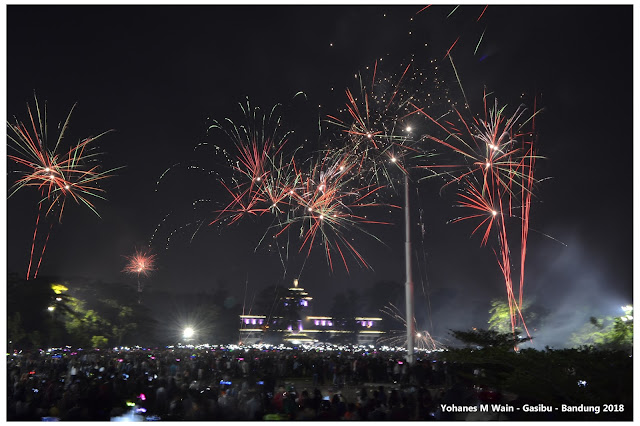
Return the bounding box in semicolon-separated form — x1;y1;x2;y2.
7;98;119;280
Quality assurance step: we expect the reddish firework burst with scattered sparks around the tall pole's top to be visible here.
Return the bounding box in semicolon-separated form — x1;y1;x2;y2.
326;60;447;193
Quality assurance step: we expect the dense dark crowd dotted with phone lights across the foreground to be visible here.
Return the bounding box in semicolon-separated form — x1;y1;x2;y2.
7;348;472;421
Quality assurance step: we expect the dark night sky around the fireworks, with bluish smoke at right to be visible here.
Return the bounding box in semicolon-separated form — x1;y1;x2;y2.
6;5;633;344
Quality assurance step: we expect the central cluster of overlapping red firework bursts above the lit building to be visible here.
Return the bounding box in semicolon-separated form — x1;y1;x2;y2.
202;101;402;271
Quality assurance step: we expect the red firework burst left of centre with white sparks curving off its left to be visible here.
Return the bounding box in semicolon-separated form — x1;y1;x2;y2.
152;101;300;255
